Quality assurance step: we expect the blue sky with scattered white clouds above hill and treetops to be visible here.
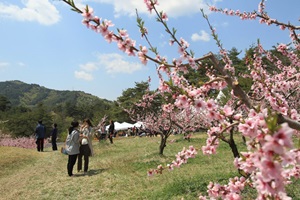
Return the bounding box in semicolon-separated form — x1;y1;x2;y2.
0;0;300;100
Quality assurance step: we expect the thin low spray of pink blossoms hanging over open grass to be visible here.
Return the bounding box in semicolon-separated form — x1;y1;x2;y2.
147;146;197;176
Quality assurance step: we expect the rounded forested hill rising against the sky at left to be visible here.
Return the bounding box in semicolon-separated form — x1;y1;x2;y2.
0;81;112;107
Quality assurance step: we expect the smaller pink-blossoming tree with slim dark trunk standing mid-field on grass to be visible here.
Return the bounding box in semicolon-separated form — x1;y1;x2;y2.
128;88;209;155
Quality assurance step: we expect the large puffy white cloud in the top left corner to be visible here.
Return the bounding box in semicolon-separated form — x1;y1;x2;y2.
0;0;60;25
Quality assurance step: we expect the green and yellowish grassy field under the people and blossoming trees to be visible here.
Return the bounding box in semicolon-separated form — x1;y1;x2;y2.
0;134;300;200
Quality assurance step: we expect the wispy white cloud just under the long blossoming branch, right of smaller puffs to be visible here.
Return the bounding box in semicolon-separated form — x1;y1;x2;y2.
98;53;142;74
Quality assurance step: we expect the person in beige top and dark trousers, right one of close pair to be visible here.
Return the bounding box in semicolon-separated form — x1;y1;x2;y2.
77;119;93;173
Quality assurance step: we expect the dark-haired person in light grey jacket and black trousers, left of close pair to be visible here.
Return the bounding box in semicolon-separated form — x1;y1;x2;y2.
66;121;79;177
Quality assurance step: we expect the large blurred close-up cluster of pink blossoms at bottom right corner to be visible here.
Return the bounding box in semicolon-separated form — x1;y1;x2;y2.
235;123;300;199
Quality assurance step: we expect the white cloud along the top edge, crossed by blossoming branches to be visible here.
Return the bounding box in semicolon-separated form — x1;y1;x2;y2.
90;0;216;17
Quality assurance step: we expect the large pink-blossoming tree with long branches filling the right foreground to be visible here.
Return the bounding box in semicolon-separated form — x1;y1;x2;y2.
63;0;300;199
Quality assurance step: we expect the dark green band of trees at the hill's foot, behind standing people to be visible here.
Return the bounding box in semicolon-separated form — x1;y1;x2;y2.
0;95;113;140
